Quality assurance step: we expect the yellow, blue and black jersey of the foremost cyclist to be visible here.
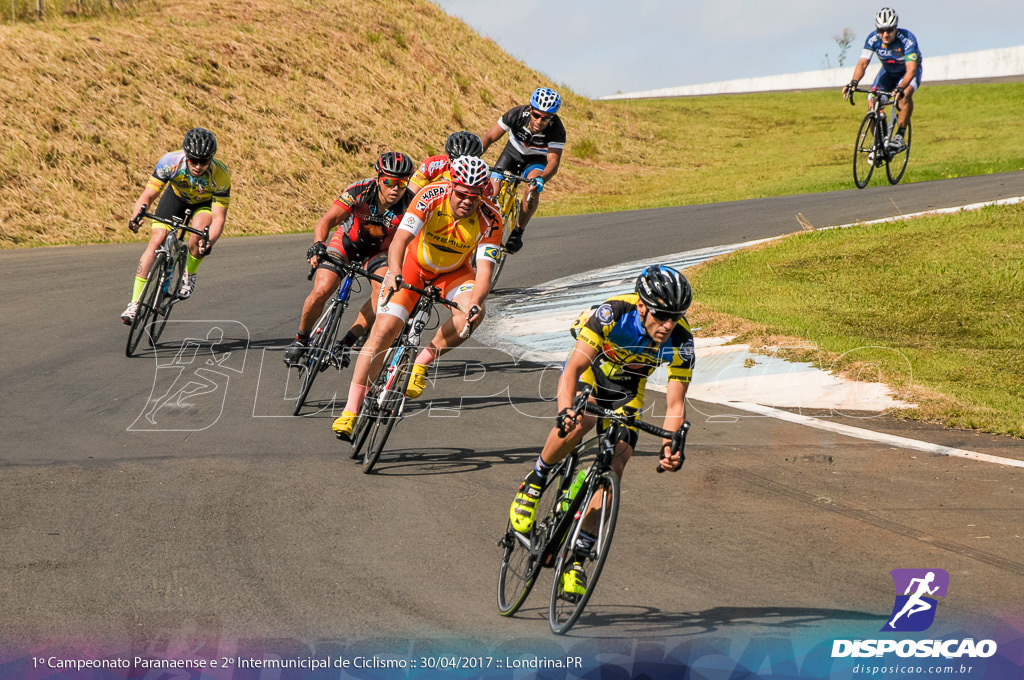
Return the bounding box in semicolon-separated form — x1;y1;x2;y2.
571;293;694;403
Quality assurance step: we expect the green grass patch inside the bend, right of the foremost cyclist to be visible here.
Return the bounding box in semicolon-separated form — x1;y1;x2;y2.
690;201;1024;437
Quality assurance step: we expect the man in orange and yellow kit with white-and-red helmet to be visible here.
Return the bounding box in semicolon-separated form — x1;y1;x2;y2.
332;156;502;439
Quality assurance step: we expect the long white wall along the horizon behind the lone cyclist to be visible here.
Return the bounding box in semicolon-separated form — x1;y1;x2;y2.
601;45;1024;99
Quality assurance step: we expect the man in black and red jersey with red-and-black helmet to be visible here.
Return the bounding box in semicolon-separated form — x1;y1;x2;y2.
285;152;415;366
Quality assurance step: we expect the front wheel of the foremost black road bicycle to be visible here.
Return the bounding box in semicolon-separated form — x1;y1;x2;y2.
548;470;620;635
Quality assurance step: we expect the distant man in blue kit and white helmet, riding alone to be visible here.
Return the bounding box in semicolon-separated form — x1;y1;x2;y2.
843;7;924;153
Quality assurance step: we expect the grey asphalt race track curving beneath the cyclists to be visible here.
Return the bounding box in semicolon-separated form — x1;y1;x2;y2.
0;173;1024;653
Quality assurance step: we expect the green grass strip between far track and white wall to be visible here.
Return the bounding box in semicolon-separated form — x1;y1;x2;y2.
545;83;1024;214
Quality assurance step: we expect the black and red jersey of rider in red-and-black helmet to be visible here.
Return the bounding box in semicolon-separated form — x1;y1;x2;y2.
328;177;413;260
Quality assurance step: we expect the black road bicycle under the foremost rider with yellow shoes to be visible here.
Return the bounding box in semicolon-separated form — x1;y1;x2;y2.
498;387;690;635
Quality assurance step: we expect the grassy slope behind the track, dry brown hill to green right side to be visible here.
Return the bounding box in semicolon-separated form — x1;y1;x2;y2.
0;0;1024;248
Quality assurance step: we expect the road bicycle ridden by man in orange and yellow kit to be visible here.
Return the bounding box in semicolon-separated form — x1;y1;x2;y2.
351;283;473;474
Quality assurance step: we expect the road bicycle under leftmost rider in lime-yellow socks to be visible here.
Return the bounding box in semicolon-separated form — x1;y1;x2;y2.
125;206;210;356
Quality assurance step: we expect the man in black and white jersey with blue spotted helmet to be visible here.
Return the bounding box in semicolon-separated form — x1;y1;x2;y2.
481;87;565;253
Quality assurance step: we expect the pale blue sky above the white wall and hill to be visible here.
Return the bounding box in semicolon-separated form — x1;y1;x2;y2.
434;0;1024;97
